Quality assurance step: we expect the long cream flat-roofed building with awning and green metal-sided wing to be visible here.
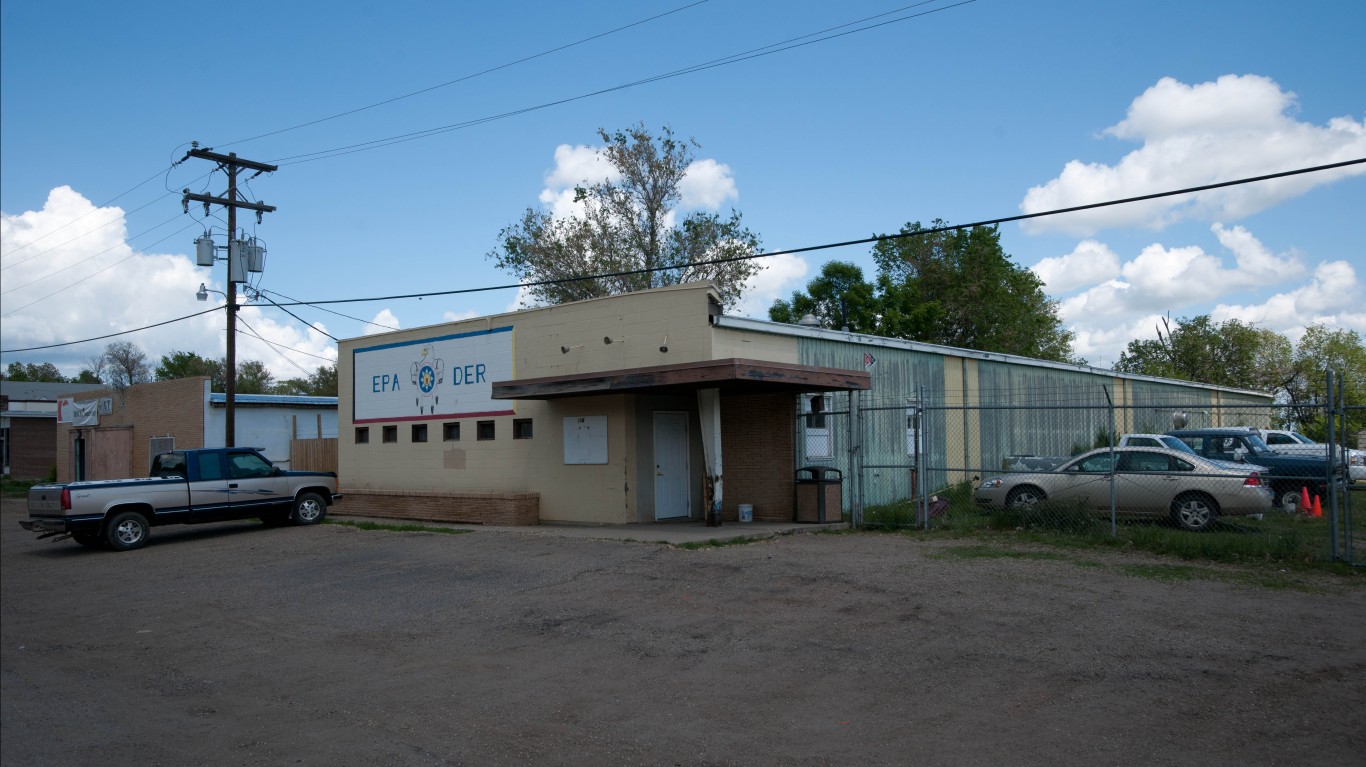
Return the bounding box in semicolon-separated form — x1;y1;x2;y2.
339;283;1270;525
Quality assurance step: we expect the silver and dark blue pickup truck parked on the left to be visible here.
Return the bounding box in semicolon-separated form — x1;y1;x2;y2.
19;447;342;551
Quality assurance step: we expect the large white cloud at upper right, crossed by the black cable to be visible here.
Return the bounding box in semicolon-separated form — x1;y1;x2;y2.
1020;75;1366;235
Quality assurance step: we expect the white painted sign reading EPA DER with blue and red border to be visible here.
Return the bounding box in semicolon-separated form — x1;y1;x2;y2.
351;327;514;424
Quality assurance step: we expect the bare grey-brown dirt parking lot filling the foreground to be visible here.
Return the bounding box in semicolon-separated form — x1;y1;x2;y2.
0;502;1366;767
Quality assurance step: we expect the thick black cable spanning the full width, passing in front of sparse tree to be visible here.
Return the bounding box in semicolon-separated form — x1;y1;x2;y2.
8;157;1366;354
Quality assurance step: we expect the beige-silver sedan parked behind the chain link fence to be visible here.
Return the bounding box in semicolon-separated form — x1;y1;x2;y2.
974;447;1272;530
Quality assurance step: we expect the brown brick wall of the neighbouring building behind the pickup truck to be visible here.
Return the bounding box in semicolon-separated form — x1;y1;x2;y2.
56;376;208;483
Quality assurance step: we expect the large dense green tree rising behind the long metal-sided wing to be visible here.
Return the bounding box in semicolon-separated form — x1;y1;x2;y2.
873;220;1078;361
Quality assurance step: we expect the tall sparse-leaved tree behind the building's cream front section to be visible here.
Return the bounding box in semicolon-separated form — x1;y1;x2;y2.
488;123;761;306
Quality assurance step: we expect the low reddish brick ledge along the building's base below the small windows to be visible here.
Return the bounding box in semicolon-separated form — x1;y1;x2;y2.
329;488;541;525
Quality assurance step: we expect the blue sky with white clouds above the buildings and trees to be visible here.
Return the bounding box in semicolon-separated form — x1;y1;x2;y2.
0;0;1366;377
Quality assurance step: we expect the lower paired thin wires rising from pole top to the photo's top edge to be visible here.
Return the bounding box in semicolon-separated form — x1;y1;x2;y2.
272;0;977;165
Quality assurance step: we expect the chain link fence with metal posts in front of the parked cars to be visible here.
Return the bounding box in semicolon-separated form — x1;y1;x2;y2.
796;387;1366;565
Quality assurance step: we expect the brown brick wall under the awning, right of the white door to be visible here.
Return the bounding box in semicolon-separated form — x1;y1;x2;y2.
721;394;796;522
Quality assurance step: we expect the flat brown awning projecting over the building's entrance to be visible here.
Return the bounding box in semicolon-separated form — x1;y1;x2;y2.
493;358;873;399
